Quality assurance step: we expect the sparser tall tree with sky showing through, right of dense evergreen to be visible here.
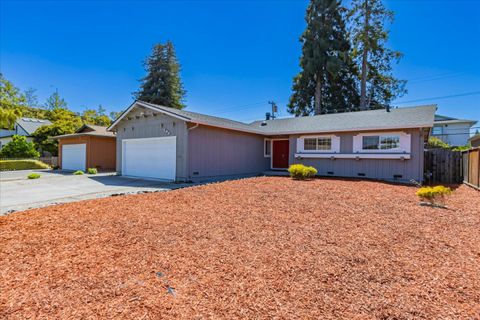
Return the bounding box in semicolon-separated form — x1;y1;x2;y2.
349;0;406;110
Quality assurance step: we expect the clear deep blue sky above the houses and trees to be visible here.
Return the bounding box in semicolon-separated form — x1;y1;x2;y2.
0;0;480;127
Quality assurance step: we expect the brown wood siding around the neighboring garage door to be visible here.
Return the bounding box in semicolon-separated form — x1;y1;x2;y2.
58;136;116;170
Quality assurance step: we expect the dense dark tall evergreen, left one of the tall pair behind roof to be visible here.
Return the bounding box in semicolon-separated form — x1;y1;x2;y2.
288;0;358;116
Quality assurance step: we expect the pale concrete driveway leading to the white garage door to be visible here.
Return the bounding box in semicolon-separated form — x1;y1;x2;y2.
0;170;191;215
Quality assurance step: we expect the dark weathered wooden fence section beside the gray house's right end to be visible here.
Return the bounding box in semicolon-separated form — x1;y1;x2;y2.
424;149;463;184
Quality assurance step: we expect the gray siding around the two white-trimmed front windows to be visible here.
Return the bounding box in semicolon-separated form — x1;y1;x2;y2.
289;129;423;182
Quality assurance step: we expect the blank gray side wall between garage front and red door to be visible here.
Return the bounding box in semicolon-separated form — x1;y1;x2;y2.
188;126;270;179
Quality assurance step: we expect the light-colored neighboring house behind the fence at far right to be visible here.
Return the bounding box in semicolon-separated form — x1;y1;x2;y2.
431;114;477;146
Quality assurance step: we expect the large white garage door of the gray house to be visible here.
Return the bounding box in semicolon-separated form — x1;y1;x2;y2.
122;137;177;180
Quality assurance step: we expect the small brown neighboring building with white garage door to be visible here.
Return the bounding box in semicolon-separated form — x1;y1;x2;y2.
54;124;116;171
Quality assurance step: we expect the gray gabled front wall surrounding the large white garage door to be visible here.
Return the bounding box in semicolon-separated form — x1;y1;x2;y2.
117;108;188;180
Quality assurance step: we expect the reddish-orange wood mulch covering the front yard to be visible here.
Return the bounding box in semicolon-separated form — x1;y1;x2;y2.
0;177;480;319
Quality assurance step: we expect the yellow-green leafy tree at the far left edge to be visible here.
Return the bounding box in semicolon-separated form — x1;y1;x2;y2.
0;73;25;129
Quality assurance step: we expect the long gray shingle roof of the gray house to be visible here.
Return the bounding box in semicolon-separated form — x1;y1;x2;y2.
107;101;437;135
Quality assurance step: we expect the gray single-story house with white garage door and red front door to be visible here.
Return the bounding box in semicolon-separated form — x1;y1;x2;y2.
108;101;436;182
